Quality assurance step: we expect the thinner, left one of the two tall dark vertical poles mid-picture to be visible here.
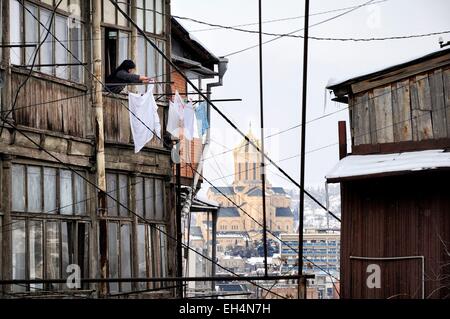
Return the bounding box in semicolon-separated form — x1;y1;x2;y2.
258;0;269;277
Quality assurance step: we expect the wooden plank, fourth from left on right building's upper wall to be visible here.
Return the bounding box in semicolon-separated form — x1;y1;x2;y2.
410;75;433;141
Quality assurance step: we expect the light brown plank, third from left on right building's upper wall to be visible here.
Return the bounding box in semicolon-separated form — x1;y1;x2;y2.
392;80;412;142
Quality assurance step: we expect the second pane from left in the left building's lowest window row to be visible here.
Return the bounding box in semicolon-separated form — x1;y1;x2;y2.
28;221;44;291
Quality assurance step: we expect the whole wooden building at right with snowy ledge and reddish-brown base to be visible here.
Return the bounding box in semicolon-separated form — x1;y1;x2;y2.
327;49;450;298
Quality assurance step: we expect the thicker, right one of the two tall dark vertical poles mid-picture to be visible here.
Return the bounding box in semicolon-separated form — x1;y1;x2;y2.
298;0;309;299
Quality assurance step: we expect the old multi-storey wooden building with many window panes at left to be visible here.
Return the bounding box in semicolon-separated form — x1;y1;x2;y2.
0;0;176;298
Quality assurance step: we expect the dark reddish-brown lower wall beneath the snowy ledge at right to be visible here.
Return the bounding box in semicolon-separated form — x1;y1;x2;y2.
341;172;450;298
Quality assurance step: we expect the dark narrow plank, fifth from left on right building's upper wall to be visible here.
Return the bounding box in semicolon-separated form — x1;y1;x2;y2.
429;70;447;138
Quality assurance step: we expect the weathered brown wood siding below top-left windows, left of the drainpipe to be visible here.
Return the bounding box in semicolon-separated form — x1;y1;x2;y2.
11;72;88;137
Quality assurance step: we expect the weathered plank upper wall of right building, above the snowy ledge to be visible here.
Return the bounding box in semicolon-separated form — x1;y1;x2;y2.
350;66;450;146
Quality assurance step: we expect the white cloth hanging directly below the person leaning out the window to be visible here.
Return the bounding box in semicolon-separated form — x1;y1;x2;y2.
128;84;161;153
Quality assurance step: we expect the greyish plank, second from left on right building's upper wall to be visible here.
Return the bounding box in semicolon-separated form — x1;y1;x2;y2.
373;85;394;143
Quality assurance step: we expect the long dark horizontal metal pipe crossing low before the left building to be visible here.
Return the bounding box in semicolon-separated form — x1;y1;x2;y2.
0;275;314;285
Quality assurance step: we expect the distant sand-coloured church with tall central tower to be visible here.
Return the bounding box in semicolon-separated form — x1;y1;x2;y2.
208;129;294;249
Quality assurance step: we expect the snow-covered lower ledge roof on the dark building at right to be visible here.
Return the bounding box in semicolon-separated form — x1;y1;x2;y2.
326;150;450;182
